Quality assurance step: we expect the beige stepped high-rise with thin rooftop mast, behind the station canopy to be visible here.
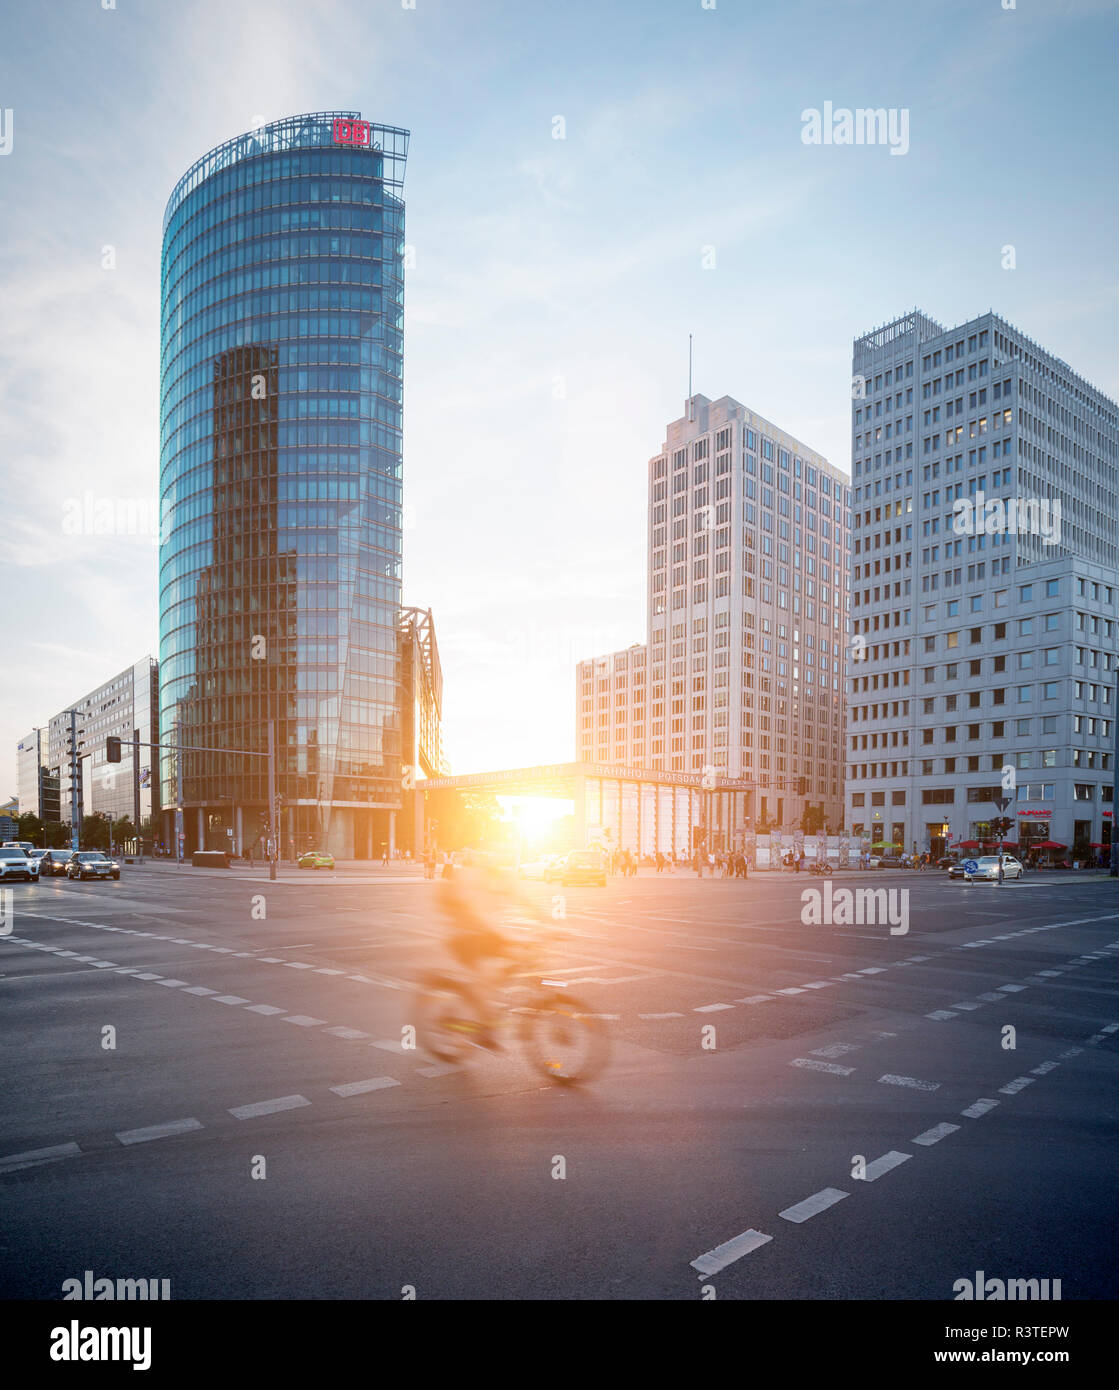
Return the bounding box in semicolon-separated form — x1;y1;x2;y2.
577;396;851;842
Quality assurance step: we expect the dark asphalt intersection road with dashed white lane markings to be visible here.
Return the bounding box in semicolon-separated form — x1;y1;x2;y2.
0;866;1119;1300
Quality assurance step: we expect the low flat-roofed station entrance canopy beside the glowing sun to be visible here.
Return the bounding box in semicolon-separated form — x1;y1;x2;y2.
416;763;756;855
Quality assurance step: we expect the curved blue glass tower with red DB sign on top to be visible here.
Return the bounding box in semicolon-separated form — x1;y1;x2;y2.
160;111;407;856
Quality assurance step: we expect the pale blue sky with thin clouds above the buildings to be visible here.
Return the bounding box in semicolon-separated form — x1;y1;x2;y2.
0;0;1119;795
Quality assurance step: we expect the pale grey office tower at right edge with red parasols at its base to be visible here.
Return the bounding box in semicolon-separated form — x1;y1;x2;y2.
847;310;1119;855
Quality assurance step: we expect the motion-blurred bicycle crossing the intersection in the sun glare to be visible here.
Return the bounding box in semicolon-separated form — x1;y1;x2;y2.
413;931;610;1086
